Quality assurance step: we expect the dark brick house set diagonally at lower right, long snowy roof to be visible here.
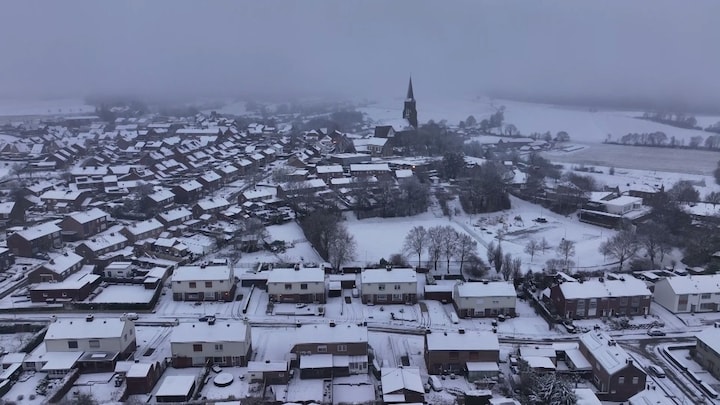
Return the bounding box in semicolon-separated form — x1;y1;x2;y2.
580;331;647;401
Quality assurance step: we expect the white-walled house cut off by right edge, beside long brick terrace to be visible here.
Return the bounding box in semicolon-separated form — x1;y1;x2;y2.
653;274;720;314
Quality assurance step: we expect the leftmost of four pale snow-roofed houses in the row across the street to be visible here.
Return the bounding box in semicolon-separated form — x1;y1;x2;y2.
171;265;236;301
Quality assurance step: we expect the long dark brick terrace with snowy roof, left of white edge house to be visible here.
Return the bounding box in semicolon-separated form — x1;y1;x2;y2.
545;276;652;319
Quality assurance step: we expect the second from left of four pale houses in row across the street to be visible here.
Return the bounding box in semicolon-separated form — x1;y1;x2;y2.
267;265;325;304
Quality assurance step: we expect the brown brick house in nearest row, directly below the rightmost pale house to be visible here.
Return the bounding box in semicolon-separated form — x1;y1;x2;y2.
425;329;500;374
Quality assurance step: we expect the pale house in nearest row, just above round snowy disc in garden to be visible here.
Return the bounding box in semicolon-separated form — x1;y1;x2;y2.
170;321;252;368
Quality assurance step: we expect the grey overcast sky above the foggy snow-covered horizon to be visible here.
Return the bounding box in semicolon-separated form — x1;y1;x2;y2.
0;0;720;109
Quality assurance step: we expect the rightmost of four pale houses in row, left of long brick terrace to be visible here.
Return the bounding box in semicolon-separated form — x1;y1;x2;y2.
453;281;517;318
